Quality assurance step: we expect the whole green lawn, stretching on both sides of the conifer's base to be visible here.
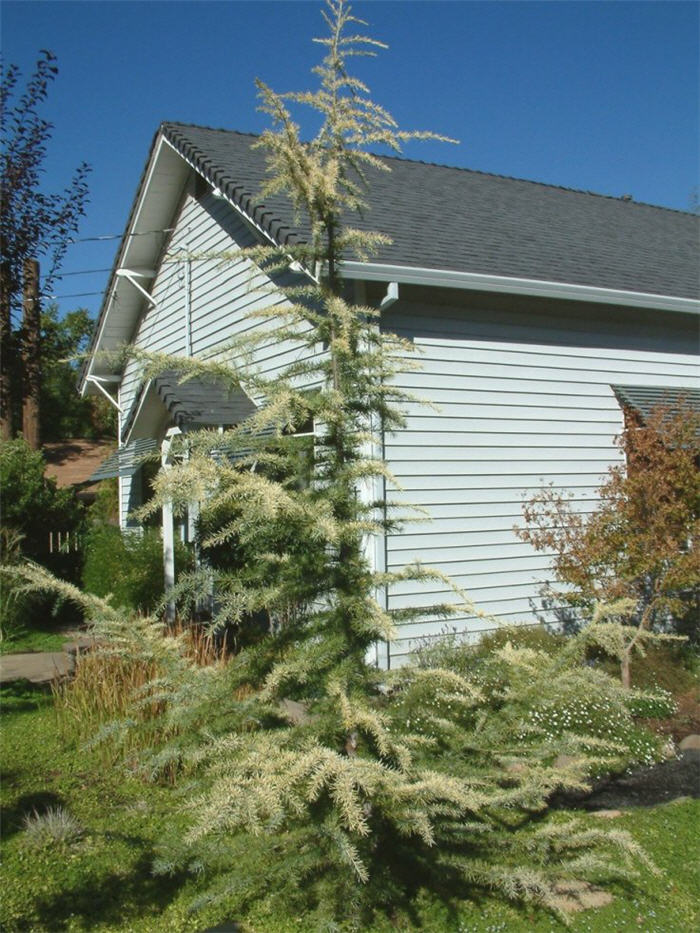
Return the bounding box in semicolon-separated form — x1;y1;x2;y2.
0;686;700;933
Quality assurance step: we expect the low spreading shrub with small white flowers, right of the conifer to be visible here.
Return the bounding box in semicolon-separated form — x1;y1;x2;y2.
410;626;675;777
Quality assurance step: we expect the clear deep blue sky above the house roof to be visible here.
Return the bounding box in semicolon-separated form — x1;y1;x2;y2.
0;0;700;320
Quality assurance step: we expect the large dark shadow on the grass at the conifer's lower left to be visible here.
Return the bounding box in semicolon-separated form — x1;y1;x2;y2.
20;851;191;931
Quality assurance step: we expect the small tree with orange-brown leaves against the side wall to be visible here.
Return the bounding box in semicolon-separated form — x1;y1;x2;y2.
516;405;700;686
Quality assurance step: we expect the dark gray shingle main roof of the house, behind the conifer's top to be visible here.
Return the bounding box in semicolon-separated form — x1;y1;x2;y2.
162;123;700;298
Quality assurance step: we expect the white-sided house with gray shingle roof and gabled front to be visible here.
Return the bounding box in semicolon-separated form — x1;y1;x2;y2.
82;123;700;666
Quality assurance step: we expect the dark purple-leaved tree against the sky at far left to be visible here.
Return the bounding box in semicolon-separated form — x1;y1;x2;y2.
0;50;89;438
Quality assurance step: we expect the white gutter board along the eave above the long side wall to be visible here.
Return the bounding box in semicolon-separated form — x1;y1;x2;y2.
341;262;700;314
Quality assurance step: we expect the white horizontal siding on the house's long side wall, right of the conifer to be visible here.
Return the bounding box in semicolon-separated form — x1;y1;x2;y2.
385;301;700;666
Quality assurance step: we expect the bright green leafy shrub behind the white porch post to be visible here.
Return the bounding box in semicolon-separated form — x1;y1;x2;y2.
83;525;193;612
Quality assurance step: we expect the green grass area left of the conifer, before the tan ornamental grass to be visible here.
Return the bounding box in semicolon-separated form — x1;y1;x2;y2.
0;684;206;933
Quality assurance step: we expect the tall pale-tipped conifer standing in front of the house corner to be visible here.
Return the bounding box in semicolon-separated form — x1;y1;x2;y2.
131;0;656;928
